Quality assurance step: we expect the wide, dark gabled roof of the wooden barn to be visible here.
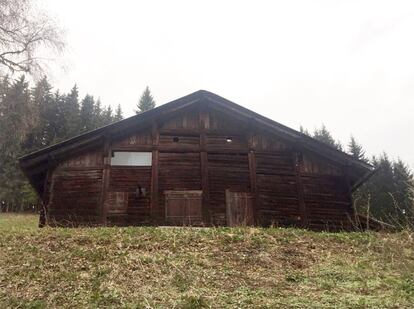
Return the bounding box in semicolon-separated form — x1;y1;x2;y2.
19;90;372;194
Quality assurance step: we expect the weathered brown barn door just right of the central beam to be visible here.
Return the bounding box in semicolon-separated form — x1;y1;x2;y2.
226;190;254;226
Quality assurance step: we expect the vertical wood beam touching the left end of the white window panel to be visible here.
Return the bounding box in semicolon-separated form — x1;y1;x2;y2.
100;135;112;225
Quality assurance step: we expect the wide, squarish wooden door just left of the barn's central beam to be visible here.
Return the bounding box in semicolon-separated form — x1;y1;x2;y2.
164;190;203;225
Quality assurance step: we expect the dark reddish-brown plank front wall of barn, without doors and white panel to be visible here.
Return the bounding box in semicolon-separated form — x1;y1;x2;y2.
45;106;352;229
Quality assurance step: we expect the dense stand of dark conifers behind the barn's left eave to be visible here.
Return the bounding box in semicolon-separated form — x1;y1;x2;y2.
0;76;131;211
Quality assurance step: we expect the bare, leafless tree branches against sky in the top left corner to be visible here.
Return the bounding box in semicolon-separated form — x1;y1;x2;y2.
0;0;65;74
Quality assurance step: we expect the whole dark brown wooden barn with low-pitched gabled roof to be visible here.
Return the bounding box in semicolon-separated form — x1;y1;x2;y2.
20;90;372;229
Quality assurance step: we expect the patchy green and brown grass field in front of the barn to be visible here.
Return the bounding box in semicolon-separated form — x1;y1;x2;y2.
0;214;414;308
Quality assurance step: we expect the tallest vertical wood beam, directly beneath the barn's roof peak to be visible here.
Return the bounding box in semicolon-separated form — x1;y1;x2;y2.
199;107;211;225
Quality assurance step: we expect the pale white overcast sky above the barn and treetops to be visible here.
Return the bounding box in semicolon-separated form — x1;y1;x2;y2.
40;0;414;167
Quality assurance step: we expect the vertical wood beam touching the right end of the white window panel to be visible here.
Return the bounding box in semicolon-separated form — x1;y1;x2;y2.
150;122;163;223
